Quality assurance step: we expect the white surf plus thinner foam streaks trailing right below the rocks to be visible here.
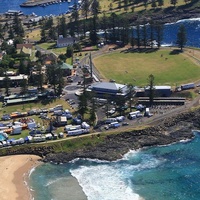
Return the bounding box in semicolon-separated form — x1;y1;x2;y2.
70;150;163;200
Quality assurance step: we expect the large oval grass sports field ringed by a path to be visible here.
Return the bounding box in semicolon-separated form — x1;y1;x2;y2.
93;49;200;86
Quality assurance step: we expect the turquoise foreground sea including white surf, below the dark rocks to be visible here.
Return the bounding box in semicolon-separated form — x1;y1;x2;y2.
30;133;200;200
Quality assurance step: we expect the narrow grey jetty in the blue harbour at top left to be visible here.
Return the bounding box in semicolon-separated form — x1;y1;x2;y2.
20;0;69;7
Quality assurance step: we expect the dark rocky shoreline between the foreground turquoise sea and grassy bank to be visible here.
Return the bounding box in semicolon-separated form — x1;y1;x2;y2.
43;109;200;164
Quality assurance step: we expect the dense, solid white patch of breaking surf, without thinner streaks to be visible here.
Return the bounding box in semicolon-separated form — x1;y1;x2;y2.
70;165;139;200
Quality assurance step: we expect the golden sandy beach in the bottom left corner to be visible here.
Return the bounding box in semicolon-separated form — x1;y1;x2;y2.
0;155;40;200
